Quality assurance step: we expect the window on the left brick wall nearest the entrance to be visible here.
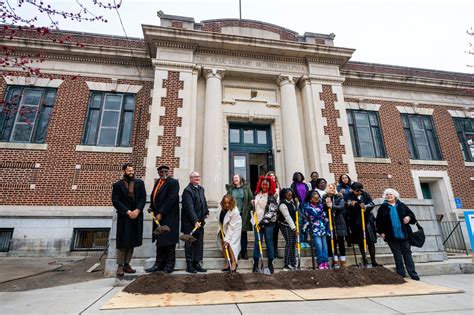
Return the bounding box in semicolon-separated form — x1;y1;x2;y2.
82;92;135;147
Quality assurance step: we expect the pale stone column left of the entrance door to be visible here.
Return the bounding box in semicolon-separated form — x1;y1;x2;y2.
201;69;224;206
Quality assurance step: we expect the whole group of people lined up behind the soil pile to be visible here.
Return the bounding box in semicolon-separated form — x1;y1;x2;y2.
112;164;419;280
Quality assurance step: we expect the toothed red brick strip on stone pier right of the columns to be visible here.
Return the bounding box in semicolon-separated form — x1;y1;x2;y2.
319;85;348;178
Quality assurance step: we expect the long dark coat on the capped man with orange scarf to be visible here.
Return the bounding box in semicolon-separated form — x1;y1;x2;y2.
150;177;179;247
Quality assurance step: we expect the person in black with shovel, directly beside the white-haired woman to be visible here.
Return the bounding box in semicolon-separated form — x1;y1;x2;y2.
344;182;381;267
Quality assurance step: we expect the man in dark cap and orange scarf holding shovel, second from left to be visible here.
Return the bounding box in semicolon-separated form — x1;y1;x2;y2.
145;165;179;273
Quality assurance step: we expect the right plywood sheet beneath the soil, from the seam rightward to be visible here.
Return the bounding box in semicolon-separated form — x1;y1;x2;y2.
292;280;463;301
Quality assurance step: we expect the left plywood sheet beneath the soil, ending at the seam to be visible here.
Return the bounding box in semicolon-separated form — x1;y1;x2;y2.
101;290;303;310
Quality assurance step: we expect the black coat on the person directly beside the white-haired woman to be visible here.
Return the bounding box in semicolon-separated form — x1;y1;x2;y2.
344;191;377;243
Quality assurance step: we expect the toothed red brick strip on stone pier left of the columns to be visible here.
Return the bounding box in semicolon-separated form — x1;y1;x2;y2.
156;71;184;175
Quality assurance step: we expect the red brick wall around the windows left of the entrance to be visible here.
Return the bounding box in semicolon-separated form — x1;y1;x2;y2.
0;73;153;206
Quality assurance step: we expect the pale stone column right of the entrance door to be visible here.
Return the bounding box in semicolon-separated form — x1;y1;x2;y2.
277;75;305;185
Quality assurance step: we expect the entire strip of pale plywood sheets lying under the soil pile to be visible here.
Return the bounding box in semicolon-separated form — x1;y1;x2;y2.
101;280;463;310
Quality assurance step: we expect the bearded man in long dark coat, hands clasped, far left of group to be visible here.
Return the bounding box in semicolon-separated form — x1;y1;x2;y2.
112;163;146;277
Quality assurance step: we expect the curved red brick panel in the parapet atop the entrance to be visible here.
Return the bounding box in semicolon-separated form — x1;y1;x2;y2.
202;19;298;42
